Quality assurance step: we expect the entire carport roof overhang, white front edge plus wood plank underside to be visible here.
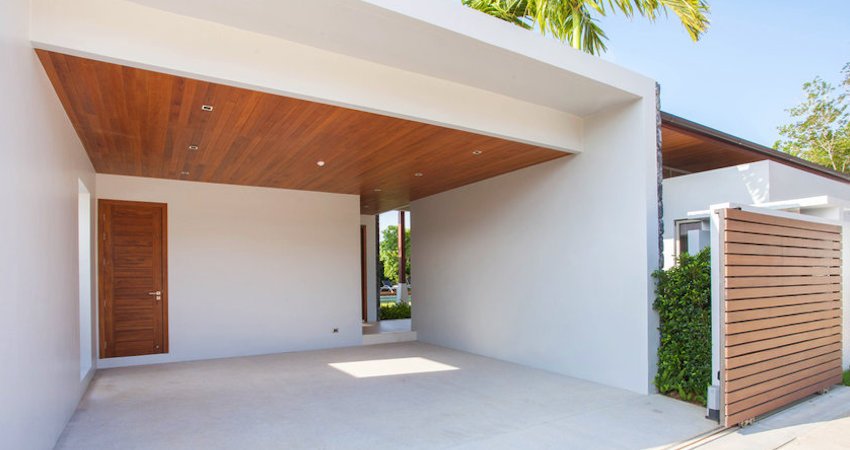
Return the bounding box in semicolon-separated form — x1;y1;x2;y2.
31;0;655;214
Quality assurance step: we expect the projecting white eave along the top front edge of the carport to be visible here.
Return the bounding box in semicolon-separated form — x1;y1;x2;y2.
122;0;654;116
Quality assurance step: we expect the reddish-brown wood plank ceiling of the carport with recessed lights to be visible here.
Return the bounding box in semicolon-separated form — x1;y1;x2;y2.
36;50;568;214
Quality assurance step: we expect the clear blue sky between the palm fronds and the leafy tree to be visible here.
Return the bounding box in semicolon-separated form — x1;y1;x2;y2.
600;0;850;146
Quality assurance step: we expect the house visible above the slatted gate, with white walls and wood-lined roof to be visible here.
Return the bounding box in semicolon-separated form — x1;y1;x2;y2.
662;113;850;267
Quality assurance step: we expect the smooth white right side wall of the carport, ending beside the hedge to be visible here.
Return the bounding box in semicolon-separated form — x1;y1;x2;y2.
411;99;658;393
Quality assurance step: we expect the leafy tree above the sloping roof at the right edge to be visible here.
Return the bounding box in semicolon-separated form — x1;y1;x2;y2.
774;63;850;173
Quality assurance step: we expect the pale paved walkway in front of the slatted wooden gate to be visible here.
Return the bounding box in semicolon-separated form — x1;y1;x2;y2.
693;386;850;450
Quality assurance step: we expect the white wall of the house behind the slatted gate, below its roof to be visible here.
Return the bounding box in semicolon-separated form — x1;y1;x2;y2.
664;161;850;366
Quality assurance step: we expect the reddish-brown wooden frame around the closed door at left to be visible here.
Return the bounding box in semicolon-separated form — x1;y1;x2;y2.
97;198;168;359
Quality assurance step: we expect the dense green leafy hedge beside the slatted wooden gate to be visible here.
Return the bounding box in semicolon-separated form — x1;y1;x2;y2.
653;248;711;404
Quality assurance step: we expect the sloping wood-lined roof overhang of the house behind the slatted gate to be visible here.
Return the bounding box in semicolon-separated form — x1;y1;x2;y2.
661;112;850;182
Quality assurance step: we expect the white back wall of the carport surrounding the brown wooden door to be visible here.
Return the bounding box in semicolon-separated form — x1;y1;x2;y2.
97;174;361;367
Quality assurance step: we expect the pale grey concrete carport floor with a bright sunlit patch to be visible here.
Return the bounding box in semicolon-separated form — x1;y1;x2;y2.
57;342;716;450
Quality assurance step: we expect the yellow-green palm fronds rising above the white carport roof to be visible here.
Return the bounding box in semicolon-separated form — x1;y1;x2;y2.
462;0;709;55
